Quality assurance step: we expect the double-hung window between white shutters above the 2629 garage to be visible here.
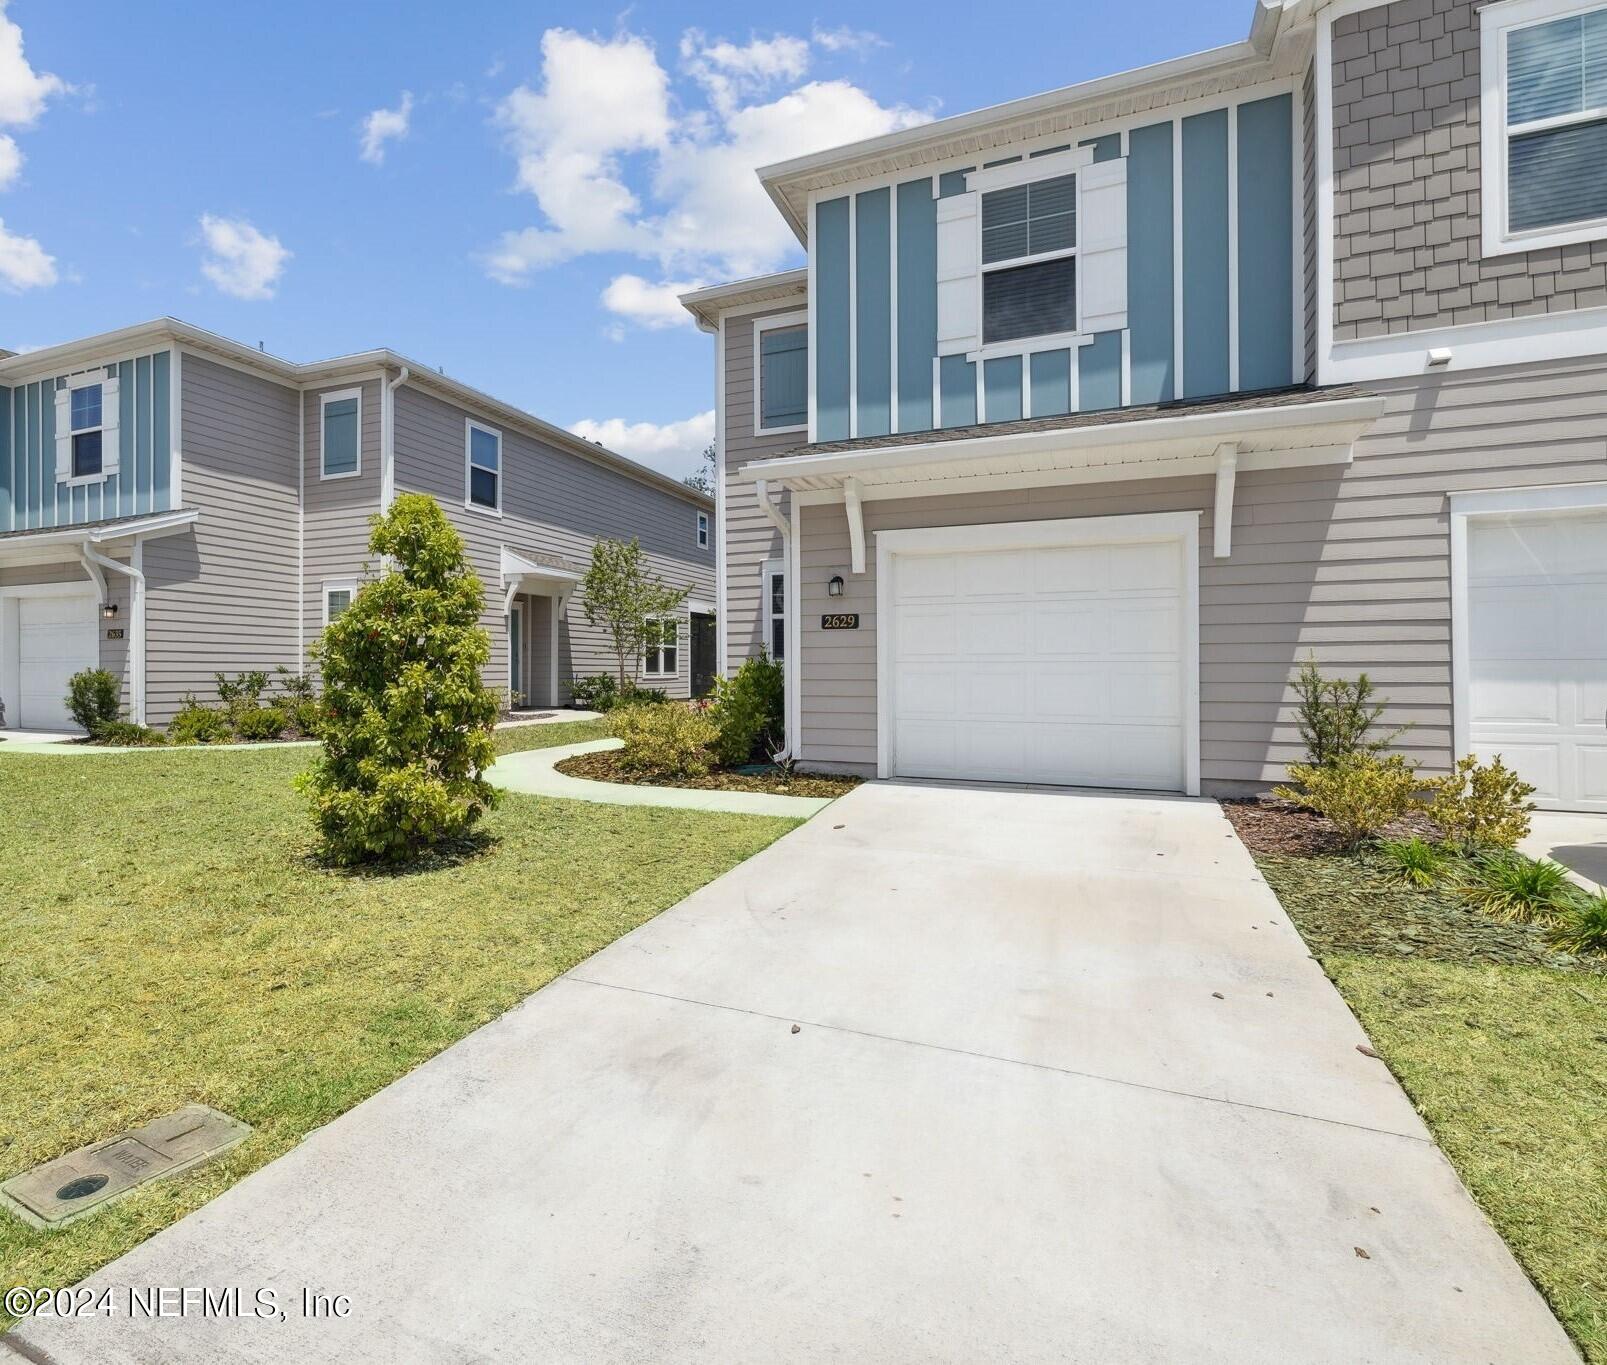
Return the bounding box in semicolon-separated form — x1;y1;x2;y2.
982;175;1077;346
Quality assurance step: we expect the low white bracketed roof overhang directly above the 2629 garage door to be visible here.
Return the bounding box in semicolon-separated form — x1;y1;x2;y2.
736;396;1384;502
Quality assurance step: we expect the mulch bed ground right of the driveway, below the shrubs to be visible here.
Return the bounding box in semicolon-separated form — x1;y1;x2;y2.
1221;797;1607;971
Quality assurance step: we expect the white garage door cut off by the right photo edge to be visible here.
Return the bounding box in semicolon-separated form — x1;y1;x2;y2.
1467;513;1607;810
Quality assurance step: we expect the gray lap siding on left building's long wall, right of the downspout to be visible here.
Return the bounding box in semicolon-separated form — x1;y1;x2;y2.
395;384;714;699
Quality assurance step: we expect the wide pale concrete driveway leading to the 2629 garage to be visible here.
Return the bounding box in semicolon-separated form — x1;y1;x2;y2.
0;785;1576;1365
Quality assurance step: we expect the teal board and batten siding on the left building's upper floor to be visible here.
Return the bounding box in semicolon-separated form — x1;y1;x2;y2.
0;350;172;532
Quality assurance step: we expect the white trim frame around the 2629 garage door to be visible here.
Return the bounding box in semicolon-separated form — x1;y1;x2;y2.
874;511;1200;796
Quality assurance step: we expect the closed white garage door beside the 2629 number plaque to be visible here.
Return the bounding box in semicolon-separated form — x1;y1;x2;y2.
889;540;1188;791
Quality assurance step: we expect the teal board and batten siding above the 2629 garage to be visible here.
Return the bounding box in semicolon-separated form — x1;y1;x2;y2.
815;93;1295;441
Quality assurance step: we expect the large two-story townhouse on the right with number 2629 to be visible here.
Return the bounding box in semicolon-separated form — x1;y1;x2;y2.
683;0;1607;810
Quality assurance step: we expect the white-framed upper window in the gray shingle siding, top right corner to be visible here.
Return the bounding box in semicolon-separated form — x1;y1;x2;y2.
1506;10;1607;233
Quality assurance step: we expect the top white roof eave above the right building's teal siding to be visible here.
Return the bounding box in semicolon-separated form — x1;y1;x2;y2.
757;0;1304;241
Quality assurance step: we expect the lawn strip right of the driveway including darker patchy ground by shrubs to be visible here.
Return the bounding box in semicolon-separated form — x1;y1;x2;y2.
1257;855;1607;1365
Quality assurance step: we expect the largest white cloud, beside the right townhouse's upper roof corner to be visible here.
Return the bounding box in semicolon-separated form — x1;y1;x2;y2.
482;29;929;305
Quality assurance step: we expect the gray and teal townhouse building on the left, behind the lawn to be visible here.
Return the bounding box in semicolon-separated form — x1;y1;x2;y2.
0;318;717;730
